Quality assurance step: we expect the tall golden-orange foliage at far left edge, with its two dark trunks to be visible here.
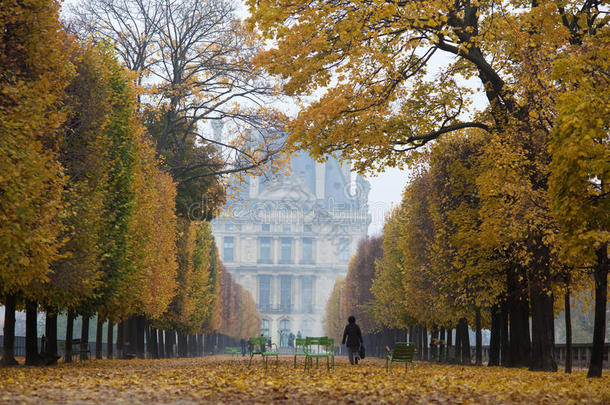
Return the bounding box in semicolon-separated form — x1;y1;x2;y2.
0;0;72;365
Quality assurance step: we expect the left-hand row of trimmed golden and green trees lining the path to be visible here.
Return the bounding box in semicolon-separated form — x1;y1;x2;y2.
0;0;256;365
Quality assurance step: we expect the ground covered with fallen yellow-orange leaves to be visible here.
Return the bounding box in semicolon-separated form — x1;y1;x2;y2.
0;357;610;405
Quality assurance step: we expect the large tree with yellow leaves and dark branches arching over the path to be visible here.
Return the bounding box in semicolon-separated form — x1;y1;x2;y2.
248;0;607;370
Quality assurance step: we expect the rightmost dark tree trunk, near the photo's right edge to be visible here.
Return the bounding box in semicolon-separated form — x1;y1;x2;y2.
587;243;610;378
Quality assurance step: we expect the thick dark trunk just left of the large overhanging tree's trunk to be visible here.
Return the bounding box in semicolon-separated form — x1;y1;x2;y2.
508;266;530;367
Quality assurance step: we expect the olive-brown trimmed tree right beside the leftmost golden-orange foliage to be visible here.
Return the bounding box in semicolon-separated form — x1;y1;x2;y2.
41;42;112;361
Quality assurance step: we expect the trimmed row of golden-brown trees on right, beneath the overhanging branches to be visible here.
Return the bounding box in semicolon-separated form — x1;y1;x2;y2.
326;132;605;372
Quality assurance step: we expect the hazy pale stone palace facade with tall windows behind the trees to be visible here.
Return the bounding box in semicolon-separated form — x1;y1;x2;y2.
212;153;370;347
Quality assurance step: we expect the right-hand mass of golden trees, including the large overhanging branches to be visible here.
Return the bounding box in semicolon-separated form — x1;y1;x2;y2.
248;0;610;376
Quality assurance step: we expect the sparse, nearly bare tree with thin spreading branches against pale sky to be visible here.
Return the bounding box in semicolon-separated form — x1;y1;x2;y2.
71;0;283;200
